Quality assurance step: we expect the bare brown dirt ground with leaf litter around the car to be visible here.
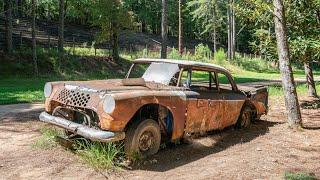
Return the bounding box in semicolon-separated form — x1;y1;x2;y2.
0;99;320;179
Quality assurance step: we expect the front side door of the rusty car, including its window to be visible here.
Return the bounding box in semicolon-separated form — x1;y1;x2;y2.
185;71;222;133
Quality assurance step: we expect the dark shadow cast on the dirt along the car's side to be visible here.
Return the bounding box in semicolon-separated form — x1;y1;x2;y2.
133;120;279;172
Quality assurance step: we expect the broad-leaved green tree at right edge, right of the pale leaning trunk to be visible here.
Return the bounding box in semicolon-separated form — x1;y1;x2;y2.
286;0;320;97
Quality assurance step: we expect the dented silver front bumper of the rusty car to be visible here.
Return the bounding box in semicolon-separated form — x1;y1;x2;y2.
39;112;125;142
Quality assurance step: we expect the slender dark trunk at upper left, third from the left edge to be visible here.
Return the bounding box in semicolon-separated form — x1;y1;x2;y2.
58;0;64;65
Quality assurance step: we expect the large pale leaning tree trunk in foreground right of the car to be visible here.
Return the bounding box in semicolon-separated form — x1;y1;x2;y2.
273;0;302;128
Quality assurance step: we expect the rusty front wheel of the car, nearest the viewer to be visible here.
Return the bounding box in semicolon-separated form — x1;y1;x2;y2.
124;119;161;157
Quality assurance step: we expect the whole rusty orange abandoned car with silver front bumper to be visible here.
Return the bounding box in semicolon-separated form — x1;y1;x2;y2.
40;58;268;156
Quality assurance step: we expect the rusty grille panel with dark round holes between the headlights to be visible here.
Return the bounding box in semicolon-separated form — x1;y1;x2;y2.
57;89;90;107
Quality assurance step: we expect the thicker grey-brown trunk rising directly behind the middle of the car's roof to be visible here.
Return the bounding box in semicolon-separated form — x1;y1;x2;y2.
161;0;168;59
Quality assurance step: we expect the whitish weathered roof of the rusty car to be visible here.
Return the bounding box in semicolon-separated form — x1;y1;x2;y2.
133;58;230;74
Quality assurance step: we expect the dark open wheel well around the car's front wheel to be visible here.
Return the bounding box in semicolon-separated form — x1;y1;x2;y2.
125;104;174;140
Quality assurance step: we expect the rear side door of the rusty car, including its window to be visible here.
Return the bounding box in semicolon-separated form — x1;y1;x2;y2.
218;73;246;129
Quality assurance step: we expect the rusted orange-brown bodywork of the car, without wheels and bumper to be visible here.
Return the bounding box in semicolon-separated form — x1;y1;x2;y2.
41;59;268;143
